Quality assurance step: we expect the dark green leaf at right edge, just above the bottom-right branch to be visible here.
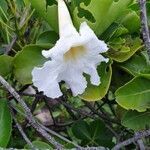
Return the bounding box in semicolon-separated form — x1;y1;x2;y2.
121;111;150;131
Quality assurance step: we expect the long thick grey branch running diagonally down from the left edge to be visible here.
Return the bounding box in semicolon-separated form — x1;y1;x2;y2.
0;76;63;149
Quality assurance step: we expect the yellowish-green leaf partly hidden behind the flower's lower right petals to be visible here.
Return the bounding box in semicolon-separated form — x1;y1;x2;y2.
80;62;112;101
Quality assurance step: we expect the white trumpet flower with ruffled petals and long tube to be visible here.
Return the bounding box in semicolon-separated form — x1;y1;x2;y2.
32;0;108;98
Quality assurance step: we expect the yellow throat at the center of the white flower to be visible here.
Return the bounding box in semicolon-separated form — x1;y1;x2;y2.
64;46;86;61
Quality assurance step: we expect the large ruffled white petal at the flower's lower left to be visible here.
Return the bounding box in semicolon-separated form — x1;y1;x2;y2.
32;61;62;98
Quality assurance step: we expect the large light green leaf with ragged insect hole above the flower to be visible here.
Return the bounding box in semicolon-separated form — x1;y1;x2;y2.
72;0;133;35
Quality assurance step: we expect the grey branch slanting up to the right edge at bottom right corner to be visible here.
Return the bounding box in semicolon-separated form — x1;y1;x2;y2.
113;130;150;150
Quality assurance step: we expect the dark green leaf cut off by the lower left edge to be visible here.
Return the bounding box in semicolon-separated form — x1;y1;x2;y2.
0;99;12;148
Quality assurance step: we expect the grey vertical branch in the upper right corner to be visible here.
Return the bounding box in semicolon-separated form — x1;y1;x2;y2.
139;0;150;59
